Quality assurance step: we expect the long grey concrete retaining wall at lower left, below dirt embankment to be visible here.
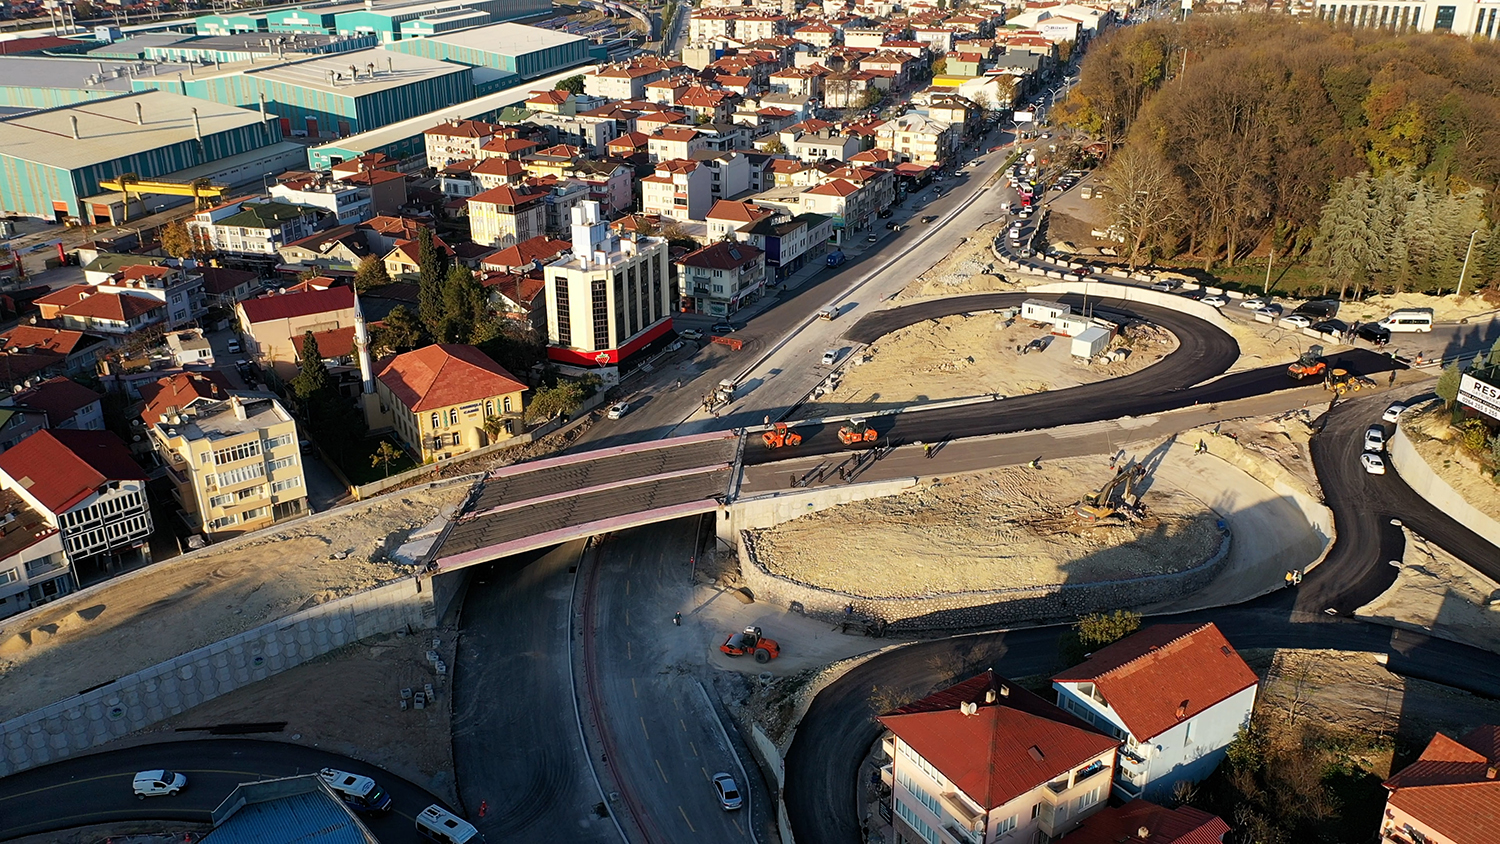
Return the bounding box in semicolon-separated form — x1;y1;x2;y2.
0;579;437;777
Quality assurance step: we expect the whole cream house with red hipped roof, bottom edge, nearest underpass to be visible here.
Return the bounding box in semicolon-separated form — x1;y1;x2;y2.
879;672;1119;843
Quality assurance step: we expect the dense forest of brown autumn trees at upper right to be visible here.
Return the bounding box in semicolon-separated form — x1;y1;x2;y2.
1056;15;1500;295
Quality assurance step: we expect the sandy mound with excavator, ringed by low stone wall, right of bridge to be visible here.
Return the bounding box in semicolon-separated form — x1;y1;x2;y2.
756;459;1220;598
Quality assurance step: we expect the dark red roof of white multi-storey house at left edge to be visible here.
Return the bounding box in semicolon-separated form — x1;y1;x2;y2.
0;429;146;513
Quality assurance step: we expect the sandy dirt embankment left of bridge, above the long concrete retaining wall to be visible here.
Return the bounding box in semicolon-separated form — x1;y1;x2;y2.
0;484;468;720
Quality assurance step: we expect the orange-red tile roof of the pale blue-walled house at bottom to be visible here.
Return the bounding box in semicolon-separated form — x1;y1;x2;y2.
1052;622;1259;741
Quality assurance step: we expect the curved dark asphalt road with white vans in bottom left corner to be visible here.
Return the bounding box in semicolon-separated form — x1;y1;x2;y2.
0;739;443;844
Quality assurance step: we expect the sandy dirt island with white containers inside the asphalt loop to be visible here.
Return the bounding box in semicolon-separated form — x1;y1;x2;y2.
804;313;1178;417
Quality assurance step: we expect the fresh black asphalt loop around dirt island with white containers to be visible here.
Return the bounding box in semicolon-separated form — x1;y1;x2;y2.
746;294;1394;465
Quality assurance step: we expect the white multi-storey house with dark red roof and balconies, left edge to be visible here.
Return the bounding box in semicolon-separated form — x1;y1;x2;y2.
0;430;152;582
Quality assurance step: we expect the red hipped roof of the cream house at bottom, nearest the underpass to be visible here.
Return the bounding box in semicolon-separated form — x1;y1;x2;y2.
881;672;1119;810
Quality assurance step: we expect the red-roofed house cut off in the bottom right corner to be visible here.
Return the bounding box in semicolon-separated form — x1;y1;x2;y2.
1380;724;1500;844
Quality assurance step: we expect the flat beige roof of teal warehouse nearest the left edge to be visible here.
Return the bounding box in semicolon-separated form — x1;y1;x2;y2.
0;91;270;169
